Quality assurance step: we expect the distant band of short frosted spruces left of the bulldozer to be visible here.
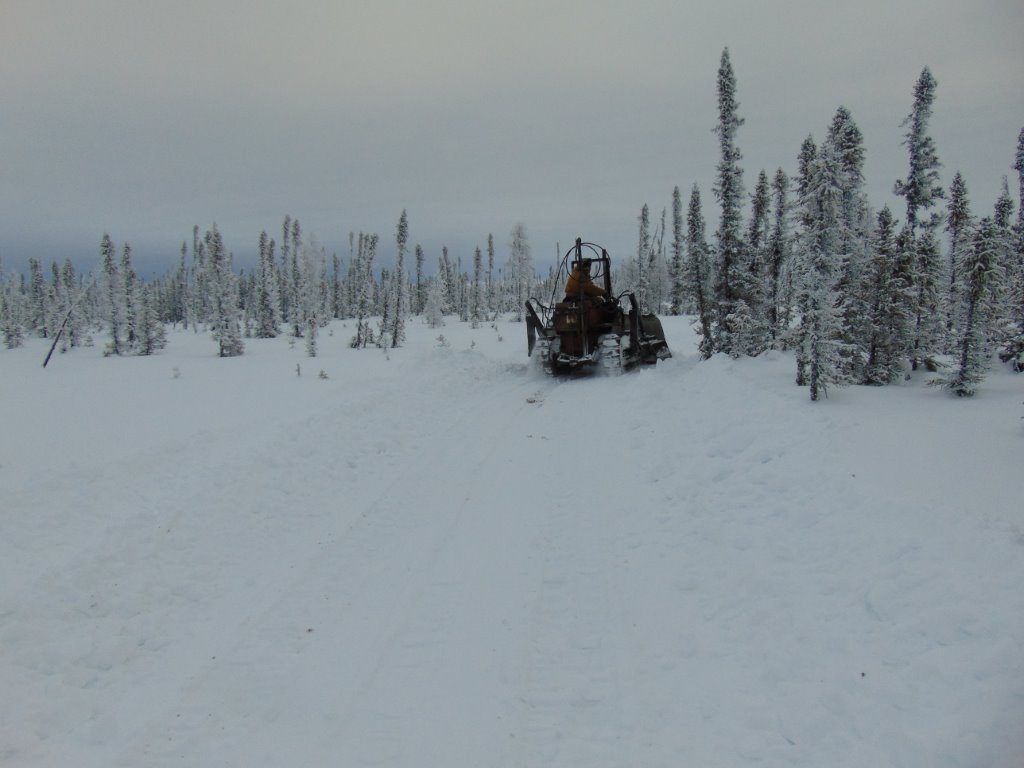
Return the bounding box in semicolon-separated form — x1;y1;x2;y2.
0;211;554;357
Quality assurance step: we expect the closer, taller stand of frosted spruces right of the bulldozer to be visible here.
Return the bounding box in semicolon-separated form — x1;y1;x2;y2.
602;49;1024;399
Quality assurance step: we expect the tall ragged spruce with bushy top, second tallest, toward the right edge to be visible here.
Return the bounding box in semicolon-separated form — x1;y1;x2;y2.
894;67;945;371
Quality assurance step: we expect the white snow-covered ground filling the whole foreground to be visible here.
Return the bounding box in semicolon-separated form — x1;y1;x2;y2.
0;317;1024;768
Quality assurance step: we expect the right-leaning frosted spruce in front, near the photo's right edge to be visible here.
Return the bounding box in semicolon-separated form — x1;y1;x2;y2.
944;216;1005;396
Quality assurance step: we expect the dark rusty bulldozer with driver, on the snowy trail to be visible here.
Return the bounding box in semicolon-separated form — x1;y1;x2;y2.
526;238;672;375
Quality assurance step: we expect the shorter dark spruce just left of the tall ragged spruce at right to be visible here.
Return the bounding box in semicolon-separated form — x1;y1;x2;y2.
863;206;912;385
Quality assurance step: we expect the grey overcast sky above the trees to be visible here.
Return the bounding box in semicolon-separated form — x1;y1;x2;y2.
0;0;1024;272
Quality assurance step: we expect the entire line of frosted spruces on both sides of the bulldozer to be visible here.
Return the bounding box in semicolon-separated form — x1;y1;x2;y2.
0;49;1024;399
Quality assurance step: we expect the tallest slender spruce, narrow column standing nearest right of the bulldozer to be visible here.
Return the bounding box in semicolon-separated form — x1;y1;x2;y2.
714;48;750;357
